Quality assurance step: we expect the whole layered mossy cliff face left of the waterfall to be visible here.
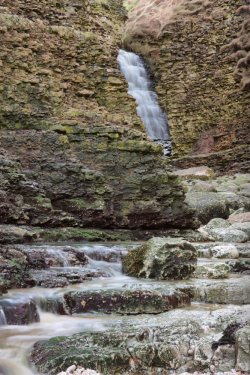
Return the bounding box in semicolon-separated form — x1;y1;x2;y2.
0;0;193;228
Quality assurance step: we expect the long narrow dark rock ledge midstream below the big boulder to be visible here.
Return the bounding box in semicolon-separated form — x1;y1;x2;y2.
63;288;190;314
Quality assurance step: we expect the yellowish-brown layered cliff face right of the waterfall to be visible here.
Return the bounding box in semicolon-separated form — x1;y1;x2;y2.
124;0;250;172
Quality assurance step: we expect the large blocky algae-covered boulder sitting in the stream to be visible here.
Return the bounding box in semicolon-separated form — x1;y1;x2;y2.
123;237;197;280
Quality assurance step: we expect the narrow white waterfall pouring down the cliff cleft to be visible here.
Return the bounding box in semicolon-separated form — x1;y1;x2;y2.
117;49;171;156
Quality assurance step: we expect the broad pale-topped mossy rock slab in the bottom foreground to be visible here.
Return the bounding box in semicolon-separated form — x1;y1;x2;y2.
31;306;248;375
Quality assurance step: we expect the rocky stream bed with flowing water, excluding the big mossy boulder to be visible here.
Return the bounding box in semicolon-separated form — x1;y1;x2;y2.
0;235;250;375
